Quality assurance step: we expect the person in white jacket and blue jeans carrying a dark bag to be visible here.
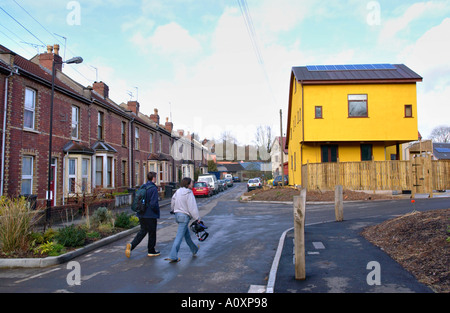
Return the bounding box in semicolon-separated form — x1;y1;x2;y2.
166;177;200;262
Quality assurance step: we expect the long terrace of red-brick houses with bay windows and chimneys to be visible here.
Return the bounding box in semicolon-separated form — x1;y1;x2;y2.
0;45;209;206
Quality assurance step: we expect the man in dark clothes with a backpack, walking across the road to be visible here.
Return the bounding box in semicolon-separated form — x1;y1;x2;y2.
125;172;160;258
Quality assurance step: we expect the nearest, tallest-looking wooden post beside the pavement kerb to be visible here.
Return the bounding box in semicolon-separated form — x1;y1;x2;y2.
294;188;306;280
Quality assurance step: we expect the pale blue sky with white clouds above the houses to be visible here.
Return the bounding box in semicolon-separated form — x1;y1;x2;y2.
0;0;450;144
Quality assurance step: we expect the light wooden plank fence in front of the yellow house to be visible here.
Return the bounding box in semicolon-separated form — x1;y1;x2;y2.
302;156;450;194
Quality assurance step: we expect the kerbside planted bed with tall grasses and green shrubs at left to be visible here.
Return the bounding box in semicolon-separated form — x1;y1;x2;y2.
0;197;139;258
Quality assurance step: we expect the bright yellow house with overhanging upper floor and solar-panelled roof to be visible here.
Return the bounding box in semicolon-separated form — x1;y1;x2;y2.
286;64;422;185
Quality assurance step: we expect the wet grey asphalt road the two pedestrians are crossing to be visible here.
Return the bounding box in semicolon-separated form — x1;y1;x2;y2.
0;183;449;293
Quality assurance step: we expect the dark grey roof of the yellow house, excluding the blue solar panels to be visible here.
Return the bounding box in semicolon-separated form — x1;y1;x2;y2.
292;64;422;84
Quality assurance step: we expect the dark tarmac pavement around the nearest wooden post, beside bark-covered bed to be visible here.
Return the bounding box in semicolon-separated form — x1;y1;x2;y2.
274;218;433;293
